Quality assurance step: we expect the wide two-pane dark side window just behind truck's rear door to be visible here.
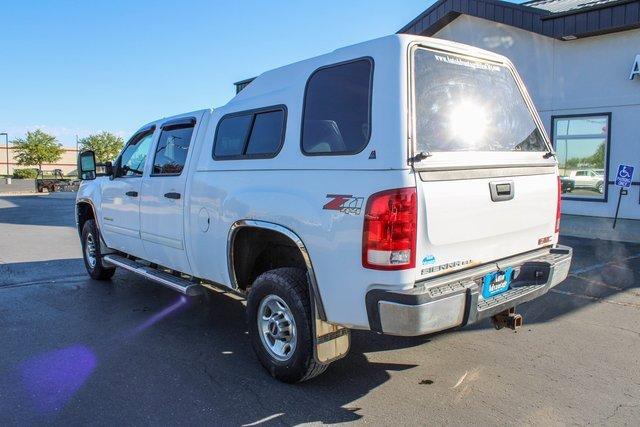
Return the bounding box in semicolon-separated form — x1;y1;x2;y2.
213;106;286;160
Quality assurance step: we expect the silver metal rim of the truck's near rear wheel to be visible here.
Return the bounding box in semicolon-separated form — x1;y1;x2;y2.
258;295;298;362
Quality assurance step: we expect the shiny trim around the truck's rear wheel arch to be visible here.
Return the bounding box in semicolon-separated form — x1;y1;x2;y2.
227;219;327;320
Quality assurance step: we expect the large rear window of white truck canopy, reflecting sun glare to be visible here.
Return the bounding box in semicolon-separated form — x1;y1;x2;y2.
414;49;546;152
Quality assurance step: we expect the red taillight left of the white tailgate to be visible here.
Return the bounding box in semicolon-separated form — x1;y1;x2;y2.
362;187;418;270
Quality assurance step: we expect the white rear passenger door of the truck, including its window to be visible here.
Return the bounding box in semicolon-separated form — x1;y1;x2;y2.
140;113;202;273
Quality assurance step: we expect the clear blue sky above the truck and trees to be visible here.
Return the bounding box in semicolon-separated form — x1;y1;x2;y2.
0;0;440;146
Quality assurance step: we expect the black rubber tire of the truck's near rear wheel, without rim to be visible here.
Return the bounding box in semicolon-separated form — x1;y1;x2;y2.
247;267;328;383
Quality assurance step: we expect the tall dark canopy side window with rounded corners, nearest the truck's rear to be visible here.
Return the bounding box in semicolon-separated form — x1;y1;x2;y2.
302;59;373;155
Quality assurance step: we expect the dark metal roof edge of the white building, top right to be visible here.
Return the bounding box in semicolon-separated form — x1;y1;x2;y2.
398;0;640;40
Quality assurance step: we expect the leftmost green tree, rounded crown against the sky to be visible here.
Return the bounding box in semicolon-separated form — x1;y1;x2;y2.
12;129;64;170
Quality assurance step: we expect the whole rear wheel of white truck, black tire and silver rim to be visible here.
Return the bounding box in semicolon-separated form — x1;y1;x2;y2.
247;268;328;383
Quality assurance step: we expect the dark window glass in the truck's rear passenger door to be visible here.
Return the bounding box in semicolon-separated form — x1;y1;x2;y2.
151;121;195;175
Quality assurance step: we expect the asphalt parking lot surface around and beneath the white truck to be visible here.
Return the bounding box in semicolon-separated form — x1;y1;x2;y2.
0;196;640;425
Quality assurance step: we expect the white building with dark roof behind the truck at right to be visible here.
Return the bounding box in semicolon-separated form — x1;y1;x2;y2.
399;0;640;219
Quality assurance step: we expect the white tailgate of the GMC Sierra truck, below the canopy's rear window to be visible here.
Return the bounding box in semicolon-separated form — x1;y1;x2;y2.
416;167;558;279
